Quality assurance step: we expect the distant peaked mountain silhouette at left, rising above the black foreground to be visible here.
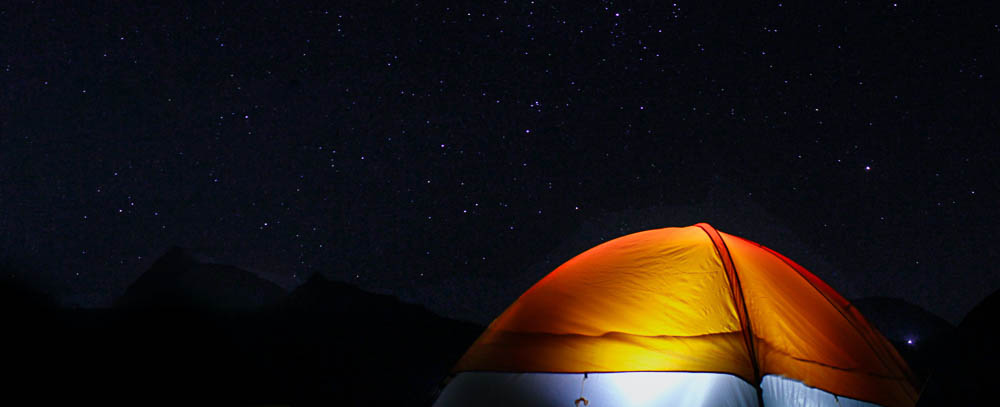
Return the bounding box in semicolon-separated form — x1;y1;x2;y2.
114;247;287;309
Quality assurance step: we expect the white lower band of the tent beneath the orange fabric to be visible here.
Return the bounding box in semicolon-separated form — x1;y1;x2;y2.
434;372;877;407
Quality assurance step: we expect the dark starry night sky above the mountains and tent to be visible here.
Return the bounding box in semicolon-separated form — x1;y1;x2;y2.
0;1;1000;323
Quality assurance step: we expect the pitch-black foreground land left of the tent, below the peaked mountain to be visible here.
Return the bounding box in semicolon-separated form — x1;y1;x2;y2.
0;276;482;406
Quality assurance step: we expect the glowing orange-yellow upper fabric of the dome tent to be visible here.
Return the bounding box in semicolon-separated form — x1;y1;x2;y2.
454;223;917;407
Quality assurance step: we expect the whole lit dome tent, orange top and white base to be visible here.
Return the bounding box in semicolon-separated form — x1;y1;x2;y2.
435;223;917;407
